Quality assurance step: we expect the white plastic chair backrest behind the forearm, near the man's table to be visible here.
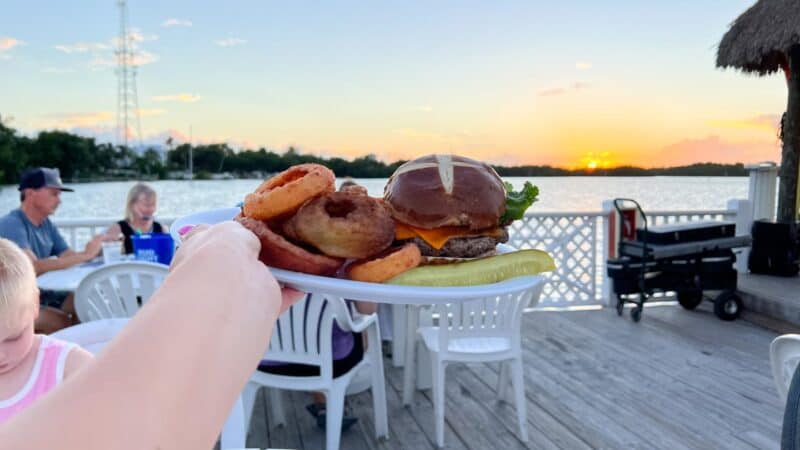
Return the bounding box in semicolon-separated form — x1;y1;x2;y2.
75;261;169;322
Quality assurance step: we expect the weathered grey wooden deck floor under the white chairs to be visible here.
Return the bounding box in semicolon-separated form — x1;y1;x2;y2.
248;302;783;449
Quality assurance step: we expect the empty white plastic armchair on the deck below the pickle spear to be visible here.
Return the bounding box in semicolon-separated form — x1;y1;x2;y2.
417;282;543;447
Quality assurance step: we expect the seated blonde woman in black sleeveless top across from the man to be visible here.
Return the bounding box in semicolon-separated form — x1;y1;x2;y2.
106;183;169;254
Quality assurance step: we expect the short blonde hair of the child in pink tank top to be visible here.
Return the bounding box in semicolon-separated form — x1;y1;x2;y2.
0;238;39;324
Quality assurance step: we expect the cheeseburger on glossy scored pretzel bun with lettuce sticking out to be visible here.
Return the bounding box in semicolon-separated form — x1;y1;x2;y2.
384;155;538;258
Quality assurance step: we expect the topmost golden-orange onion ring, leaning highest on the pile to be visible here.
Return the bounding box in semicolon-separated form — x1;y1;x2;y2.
242;163;336;220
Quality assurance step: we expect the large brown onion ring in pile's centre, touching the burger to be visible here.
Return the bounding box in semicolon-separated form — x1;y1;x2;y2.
283;190;394;259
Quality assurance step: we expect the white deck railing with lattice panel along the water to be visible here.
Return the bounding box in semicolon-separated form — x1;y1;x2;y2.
54;210;736;308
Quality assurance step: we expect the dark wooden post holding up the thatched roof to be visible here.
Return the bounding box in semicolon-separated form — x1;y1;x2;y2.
778;45;800;225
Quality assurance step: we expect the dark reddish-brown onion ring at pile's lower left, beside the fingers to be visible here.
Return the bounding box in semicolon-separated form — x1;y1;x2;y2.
234;216;343;275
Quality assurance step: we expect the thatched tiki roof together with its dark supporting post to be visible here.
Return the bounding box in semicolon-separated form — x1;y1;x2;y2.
717;0;800;223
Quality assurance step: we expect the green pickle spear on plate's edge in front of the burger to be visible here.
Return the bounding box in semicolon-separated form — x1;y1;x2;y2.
386;250;556;286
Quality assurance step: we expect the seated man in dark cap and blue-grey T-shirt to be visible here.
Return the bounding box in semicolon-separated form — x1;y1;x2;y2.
0;167;103;333
